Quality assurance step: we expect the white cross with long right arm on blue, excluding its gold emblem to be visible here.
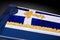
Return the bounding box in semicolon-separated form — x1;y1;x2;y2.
15;9;60;25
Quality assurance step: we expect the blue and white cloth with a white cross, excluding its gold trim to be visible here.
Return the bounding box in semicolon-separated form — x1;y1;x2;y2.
0;6;60;40
